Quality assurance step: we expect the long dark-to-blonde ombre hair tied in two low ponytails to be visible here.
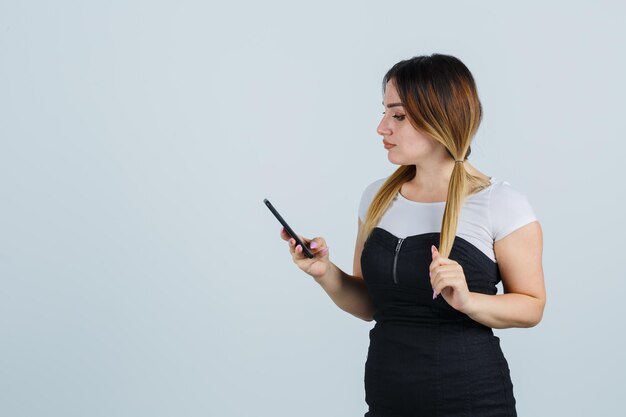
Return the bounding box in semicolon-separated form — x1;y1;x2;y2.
363;54;489;257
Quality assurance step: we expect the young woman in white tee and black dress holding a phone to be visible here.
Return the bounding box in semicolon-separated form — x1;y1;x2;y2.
281;54;546;417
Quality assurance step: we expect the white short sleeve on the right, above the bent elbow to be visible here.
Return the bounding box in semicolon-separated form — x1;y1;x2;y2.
489;181;537;242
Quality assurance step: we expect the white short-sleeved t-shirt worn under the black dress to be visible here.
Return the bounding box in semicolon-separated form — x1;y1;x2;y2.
359;177;537;262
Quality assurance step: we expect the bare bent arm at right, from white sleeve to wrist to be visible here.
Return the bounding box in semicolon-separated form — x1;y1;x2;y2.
464;221;546;329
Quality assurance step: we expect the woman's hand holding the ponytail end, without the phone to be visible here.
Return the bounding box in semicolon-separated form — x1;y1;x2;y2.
428;245;471;312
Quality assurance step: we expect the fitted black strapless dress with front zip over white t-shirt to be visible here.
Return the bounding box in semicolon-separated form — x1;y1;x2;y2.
361;227;517;417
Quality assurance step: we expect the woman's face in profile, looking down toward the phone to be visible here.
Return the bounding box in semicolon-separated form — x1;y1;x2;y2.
376;80;443;165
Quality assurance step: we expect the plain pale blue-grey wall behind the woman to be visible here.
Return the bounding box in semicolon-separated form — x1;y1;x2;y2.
0;0;626;417
